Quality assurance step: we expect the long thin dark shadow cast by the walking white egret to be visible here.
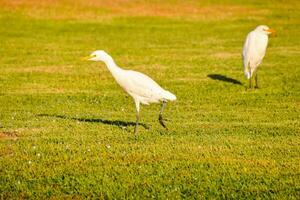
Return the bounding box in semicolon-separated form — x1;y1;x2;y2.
37;114;149;129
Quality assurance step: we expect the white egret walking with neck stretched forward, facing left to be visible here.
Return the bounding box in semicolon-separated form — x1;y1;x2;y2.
86;50;176;134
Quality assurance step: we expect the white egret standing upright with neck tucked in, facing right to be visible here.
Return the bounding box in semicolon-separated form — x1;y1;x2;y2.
243;25;275;88
